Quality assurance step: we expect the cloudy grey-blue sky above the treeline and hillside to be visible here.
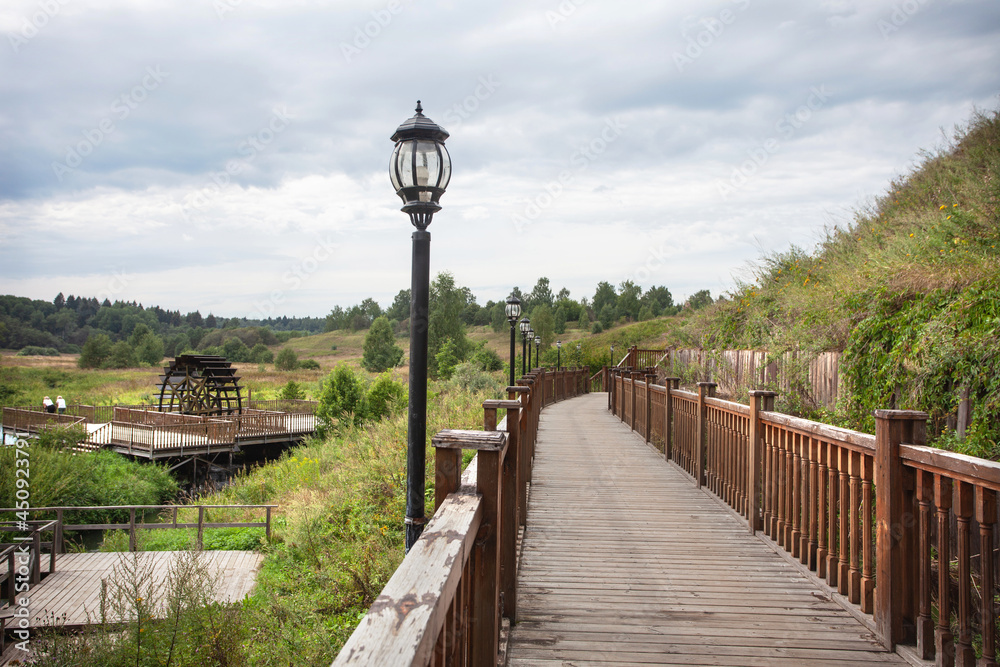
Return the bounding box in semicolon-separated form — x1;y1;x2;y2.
0;0;1000;317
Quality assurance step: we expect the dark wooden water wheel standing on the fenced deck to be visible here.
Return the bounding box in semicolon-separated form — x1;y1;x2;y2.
160;354;243;415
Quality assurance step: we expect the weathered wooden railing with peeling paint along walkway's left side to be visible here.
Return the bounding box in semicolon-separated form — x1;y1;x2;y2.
334;369;588;667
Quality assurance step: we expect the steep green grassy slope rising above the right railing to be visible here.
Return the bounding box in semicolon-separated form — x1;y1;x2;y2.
697;105;1000;457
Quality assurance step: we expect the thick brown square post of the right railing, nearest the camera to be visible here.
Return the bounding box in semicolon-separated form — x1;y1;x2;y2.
875;410;927;650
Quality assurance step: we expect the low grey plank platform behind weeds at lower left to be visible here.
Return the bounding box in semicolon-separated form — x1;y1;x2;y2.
0;551;264;628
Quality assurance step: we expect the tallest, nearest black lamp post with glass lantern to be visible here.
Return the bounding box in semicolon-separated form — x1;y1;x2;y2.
389;100;451;552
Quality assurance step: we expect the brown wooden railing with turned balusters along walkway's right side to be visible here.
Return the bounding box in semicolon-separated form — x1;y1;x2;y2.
609;369;1000;665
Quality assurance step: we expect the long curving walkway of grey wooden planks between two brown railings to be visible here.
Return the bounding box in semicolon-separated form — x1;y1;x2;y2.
507;393;906;667
